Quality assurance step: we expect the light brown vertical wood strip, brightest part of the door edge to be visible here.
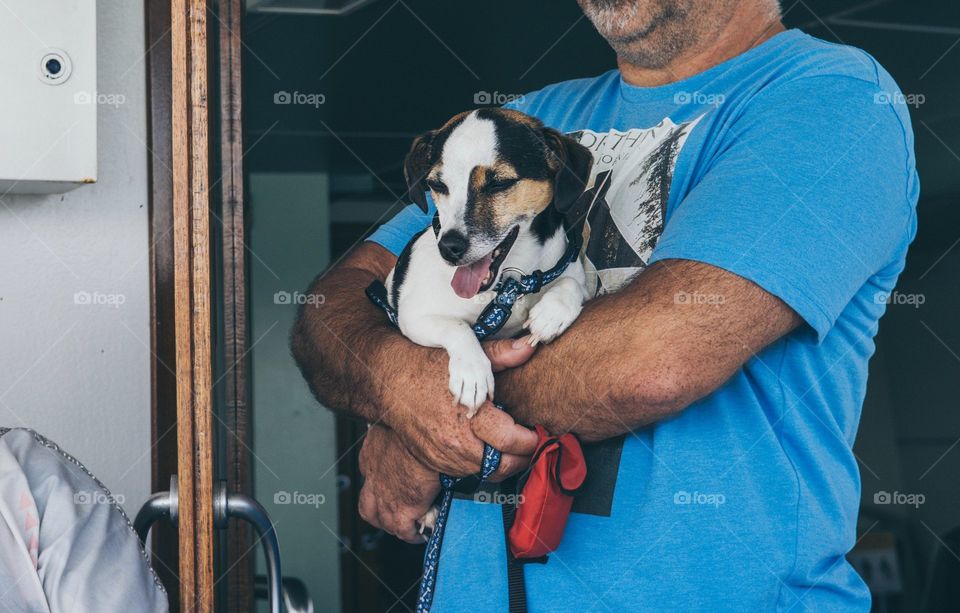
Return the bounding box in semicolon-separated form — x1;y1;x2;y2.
170;0;214;613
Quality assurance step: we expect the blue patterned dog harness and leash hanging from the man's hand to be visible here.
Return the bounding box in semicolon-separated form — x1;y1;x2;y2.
366;241;580;613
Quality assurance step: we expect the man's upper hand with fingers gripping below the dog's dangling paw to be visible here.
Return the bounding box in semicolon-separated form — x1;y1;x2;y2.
377;337;537;478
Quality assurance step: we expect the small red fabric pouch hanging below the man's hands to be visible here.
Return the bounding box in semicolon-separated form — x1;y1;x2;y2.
508;426;587;559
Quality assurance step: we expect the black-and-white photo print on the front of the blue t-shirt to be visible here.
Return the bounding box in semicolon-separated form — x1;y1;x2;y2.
567;115;703;517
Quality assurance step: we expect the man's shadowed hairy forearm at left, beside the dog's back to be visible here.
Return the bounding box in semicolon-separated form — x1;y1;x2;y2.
291;245;398;422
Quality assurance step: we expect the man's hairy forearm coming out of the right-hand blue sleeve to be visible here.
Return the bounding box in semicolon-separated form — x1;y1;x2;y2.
484;260;801;441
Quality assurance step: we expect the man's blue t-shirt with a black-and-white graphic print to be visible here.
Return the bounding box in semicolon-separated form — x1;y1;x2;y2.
370;30;919;612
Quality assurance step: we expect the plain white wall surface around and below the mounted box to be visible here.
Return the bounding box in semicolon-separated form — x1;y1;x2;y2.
0;0;150;513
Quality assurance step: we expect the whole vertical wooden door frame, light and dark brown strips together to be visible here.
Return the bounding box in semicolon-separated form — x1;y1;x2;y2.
144;0;254;611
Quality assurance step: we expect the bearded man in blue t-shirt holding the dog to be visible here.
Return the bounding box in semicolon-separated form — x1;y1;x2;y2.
293;0;919;611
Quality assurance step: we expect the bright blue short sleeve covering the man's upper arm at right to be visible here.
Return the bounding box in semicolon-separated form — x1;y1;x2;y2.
650;76;919;340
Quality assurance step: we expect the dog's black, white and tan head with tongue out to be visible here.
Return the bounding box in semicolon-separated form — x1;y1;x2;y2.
404;108;592;298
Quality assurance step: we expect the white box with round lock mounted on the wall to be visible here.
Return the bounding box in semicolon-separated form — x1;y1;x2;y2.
0;0;96;196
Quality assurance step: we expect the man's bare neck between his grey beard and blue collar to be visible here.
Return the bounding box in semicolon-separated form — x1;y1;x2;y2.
617;8;786;87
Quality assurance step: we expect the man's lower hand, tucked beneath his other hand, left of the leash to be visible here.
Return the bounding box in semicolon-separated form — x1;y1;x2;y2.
360;426;440;543
